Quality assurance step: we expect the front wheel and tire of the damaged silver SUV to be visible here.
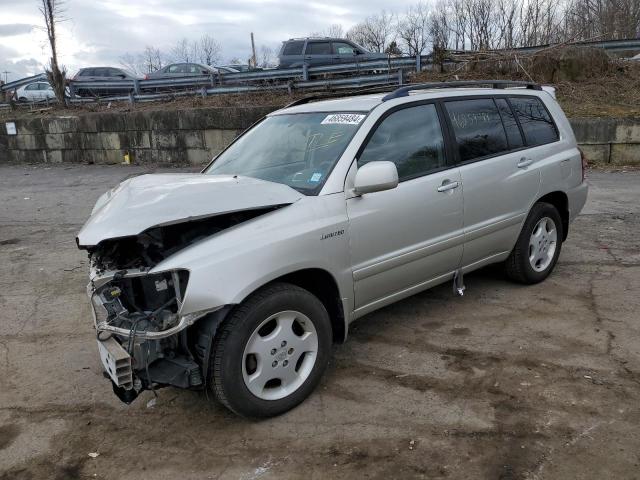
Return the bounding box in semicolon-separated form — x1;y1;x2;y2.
210;283;332;418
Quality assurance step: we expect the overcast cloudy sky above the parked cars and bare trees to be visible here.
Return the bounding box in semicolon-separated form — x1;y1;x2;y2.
0;0;416;80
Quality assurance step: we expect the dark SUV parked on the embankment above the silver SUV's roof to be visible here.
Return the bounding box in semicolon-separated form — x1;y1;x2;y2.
278;38;387;68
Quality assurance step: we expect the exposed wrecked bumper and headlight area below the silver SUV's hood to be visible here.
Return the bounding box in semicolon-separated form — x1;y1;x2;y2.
87;265;210;403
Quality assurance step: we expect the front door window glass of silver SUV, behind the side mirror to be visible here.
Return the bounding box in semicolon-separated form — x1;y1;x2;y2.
358;105;446;181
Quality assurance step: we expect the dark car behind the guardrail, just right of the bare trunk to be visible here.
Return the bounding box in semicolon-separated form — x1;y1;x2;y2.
72;67;138;97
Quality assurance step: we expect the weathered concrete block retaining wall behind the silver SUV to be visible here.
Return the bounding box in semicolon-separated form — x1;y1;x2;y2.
0;107;640;165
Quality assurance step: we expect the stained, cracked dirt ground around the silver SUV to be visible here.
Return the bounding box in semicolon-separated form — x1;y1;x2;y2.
0;165;640;480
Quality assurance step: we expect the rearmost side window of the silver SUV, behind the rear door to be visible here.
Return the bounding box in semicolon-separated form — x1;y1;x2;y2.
509;97;559;147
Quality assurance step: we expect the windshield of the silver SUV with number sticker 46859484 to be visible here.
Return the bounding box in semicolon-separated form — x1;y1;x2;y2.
205;112;365;195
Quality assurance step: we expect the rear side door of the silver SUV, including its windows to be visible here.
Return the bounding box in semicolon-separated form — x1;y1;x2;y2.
444;97;540;267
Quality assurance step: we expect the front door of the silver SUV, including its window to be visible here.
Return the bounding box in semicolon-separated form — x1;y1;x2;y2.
347;103;463;316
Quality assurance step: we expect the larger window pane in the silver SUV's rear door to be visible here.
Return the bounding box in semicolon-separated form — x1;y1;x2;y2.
445;98;508;162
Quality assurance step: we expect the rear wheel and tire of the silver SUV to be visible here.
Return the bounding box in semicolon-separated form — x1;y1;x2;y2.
505;202;563;285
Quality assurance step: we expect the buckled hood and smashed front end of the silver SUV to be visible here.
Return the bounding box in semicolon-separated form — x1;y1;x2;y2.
76;174;302;403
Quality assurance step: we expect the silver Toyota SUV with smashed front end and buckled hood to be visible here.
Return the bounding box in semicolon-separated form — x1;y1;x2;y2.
77;81;587;417
